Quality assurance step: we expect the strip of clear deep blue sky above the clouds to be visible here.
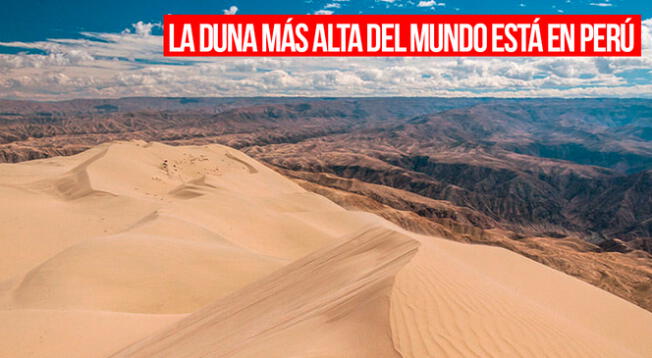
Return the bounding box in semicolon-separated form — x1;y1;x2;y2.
0;0;652;41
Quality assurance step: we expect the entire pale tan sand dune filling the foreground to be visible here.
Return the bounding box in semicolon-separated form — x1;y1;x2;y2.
0;141;652;358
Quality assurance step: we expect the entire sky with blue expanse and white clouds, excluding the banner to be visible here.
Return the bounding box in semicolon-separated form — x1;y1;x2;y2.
0;0;652;100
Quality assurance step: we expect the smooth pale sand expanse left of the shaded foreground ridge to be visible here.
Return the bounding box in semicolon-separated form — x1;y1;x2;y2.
0;142;365;357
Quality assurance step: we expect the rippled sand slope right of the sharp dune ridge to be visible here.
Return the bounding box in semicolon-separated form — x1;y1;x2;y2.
392;236;652;357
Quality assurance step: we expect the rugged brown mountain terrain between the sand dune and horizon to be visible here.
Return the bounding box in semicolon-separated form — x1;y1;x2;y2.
0;98;652;310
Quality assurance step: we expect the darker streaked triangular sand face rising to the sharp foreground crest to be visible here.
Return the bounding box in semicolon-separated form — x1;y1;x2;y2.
112;228;418;358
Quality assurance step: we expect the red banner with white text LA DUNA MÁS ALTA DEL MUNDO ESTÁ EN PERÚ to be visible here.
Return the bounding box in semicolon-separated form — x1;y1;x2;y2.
163;15;641;56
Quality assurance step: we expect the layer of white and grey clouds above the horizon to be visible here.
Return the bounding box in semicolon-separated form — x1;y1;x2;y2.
0;19;652;99
